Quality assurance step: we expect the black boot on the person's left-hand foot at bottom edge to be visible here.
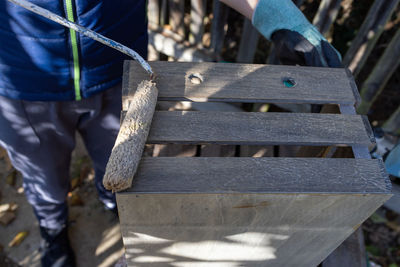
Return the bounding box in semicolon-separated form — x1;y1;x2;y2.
40;226;76;267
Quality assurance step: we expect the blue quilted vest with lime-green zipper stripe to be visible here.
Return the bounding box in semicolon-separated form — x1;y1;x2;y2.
0;0;147;101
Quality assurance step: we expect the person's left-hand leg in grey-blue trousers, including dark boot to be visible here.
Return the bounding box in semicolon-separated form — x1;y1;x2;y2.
0;97;78;266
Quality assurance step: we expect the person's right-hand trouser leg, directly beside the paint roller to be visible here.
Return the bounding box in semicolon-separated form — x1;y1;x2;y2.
78;85;122;209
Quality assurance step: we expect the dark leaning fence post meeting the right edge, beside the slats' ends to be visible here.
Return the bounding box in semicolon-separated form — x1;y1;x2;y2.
357;29;400;114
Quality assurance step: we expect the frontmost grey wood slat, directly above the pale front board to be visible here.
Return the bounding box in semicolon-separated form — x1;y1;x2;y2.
123;157;390;194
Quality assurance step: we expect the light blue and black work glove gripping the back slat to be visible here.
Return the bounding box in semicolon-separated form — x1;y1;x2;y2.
252;0;342;68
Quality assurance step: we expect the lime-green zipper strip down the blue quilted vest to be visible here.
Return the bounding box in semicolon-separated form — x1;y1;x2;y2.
65;0;82;101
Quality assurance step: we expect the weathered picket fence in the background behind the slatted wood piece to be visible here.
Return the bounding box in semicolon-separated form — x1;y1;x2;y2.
148;0;400;133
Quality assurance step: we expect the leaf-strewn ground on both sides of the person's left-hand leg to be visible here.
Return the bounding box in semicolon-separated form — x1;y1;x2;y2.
0;139;123;267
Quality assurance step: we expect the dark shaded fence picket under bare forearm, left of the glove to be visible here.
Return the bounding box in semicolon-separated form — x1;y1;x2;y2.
236;19;260;63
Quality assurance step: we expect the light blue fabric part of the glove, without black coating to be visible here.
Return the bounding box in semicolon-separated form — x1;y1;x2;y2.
252;0;326;47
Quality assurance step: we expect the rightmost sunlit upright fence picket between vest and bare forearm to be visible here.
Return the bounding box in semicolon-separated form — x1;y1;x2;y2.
189;0;207;45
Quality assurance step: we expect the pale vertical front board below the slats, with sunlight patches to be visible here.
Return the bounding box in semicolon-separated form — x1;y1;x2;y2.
117;193;388;267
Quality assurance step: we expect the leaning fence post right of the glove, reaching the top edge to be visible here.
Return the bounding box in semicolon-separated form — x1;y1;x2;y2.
343;0;399;77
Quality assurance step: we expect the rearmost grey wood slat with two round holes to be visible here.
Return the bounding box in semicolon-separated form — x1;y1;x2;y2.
123;61;356;109
